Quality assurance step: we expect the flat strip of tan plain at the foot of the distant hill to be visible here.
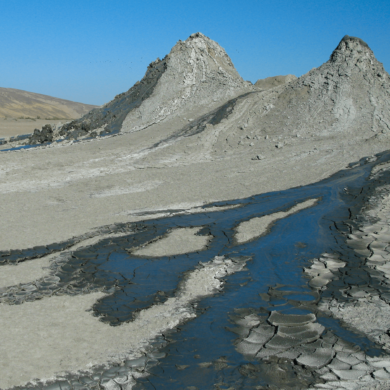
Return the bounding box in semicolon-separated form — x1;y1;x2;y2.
0;118;65;138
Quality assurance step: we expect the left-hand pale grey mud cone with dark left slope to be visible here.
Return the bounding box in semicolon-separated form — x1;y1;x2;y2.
62;33;250;137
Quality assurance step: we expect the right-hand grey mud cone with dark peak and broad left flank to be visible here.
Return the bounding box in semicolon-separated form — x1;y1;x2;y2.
195;36;390;155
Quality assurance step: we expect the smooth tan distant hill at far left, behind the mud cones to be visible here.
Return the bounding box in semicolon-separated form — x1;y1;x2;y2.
0;88;97;119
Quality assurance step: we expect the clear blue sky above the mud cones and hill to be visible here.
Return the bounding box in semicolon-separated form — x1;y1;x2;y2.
0;0;390;105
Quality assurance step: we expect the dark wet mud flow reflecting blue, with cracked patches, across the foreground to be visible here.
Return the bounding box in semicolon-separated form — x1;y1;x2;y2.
0;153;390;390
